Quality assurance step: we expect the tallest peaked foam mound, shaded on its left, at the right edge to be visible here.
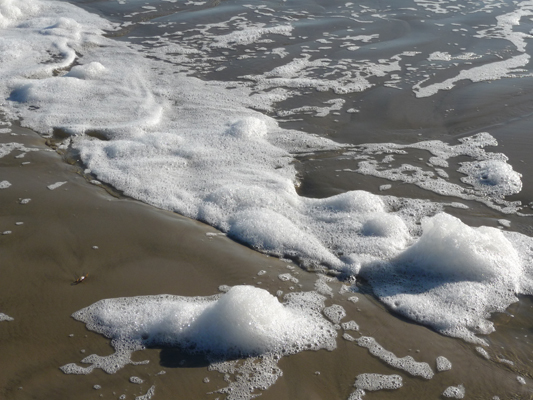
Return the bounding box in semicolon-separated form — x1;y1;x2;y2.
361;213;530;343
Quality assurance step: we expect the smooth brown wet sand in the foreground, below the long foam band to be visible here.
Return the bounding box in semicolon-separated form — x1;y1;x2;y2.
0;124;533;400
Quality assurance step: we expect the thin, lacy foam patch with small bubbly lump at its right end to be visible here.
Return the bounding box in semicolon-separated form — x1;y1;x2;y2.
345;132;522;213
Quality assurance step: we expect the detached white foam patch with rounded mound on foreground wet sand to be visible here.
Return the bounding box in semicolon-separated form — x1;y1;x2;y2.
62;286;337;373
